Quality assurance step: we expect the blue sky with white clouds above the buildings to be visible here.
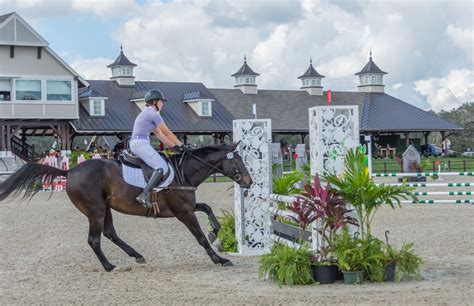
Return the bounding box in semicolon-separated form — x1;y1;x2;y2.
0;0;474;111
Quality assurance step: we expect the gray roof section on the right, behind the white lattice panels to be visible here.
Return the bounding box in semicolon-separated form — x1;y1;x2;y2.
210;89;461;132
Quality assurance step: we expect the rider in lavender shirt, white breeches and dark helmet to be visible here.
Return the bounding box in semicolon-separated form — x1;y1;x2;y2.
130;89;183;207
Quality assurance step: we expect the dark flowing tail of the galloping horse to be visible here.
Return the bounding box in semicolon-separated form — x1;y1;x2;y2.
0;163;67;201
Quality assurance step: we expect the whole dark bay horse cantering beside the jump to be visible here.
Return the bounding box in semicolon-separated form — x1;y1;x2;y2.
0;143;252;271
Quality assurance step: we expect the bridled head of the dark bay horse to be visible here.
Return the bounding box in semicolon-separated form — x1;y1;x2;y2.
222;142;253;188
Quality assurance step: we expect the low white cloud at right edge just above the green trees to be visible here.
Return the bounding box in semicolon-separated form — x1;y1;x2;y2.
415;69;474;111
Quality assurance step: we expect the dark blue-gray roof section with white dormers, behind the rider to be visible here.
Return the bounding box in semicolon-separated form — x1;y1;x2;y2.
72;80;234;134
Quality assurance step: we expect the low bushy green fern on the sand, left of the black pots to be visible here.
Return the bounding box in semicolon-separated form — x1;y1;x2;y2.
259;243;314;287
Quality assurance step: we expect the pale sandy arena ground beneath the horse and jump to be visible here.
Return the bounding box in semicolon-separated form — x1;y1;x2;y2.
0;179;474;305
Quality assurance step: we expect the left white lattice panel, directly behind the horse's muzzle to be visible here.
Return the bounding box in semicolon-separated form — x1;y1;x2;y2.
233;119;272;255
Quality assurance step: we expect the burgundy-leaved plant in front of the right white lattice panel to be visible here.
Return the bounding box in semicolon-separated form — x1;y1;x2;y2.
293;175;358;261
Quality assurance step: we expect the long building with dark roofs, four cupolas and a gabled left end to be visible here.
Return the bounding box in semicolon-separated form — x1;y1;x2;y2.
0;13;462;160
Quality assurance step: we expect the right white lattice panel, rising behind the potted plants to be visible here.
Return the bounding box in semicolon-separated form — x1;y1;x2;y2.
309;105;359;175
